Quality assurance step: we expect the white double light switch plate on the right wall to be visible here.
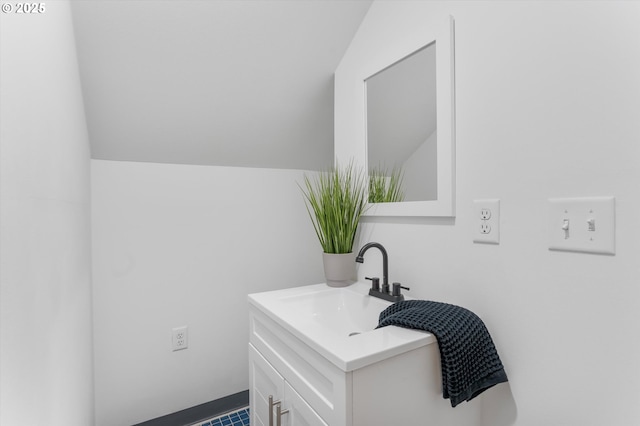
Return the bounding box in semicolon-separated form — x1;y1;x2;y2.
547;197;616;254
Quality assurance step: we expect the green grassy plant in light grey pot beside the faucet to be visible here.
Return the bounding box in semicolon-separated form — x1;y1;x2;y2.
301;162;367;287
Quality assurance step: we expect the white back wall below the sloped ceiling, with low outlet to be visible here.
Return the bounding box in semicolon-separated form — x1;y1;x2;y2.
91;160;324;426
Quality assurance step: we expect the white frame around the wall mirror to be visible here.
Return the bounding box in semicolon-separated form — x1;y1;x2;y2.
360;16;455;217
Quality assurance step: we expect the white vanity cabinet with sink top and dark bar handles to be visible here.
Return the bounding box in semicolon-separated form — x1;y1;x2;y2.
249;285;478;426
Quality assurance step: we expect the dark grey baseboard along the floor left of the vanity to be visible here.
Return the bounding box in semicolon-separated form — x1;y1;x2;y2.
134;390;249;426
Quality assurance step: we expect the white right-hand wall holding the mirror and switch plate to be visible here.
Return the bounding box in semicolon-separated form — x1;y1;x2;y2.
335;1;640;426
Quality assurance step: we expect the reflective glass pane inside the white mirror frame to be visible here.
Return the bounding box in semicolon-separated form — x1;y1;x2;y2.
366;42;438;202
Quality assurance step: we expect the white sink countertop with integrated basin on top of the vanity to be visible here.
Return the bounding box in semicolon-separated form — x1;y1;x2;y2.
249;282;436;371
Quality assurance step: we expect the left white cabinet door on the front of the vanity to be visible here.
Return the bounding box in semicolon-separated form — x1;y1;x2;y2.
249;344;284;426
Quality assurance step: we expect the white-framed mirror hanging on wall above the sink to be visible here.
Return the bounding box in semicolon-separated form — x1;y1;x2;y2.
364;17;455;216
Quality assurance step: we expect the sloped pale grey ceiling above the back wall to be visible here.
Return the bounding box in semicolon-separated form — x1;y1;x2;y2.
72;0;371;170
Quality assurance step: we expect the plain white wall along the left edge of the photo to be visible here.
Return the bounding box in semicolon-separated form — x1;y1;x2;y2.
0;1;93;426
